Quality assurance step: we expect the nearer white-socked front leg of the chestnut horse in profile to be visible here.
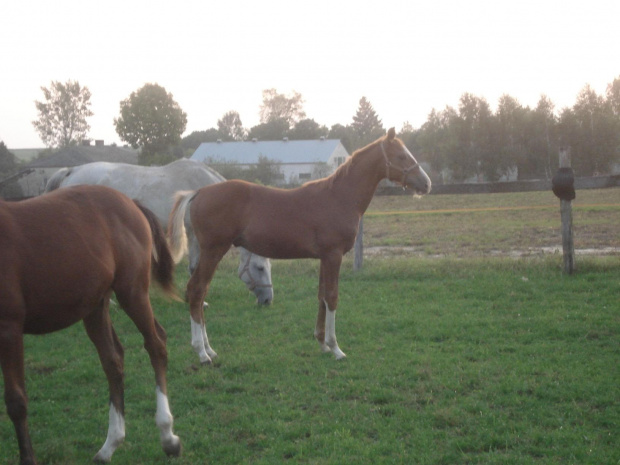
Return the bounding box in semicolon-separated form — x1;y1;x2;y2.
315;255;346;360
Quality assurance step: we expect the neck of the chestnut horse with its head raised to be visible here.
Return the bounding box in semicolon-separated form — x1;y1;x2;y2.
333;143;385;214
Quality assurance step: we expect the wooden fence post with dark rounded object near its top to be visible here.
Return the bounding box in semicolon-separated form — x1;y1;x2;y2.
552;147;575;274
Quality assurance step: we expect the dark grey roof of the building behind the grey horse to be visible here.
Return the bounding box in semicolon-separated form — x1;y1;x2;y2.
28;145;138;168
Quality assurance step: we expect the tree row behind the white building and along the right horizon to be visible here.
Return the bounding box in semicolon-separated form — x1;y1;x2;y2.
181;78;620;179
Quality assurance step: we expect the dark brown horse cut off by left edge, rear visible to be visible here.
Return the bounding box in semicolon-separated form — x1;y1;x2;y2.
0;186;181;465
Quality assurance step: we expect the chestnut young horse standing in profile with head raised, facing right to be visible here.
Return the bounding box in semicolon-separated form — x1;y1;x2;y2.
168;128;431;363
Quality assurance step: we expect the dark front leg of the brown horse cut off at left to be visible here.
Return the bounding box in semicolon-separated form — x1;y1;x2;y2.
0;323;36;465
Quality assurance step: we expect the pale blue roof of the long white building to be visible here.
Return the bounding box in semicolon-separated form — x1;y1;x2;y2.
190;139;344;165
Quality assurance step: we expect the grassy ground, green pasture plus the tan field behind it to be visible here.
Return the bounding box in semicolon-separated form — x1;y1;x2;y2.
0;189;620;465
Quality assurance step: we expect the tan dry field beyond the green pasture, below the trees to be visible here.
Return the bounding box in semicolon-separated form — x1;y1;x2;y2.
364;188;620;257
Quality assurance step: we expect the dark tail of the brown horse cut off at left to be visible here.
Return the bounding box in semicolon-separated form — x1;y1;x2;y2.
134;200;180;300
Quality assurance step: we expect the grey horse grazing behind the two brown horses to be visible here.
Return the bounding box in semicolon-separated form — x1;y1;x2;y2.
45;158;273;305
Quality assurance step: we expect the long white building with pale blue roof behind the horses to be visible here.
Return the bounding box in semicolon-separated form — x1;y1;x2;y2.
190;138;349;184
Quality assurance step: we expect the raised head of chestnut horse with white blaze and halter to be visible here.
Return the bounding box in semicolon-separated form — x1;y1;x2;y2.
379;128;431;195
